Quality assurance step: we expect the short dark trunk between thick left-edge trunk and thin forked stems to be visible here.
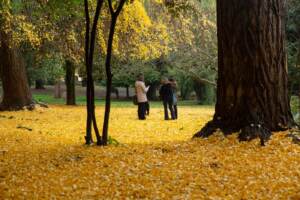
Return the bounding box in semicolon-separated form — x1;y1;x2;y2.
66;60;76;105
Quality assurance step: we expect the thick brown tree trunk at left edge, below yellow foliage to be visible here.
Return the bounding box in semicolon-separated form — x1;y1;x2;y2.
0;31;33;110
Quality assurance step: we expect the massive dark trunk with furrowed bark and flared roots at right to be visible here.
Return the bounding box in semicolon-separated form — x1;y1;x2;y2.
195;0;295;145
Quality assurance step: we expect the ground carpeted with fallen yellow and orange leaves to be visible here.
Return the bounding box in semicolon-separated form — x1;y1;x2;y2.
0;106;300;199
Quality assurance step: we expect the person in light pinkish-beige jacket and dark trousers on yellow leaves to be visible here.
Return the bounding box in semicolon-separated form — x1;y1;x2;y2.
135;74;149;120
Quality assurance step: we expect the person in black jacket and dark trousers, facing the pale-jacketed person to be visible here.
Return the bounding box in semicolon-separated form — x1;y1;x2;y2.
159;78;175;120
